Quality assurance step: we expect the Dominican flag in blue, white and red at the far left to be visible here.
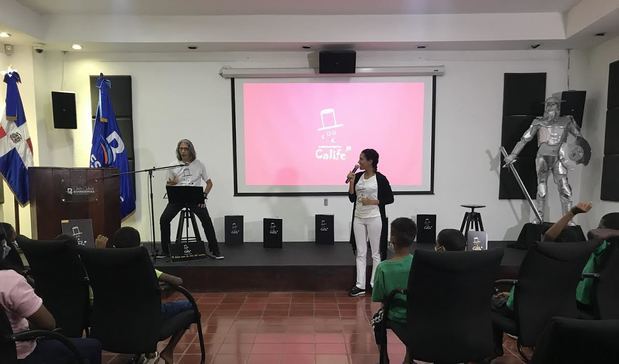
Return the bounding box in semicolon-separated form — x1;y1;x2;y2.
0;71;32;205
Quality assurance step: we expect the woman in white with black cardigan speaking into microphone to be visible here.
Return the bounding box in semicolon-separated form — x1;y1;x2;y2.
347;149;393;297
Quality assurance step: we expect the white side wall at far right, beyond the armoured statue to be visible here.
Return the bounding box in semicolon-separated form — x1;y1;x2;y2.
571;37;619;227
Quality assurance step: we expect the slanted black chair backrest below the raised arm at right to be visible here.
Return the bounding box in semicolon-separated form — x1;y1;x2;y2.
514;242;596;346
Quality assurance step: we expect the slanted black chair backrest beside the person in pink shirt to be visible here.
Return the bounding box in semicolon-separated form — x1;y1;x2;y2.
18;237;90;337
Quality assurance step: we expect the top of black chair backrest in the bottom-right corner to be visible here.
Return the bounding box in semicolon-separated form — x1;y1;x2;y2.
531;317;619;364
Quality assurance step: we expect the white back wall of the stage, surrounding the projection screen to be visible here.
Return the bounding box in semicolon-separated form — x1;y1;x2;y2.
25;51;581;241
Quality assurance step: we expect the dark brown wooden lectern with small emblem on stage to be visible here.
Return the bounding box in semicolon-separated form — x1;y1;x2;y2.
28;167;120;240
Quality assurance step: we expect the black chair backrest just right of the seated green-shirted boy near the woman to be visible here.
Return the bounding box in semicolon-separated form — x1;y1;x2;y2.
406;249;503;363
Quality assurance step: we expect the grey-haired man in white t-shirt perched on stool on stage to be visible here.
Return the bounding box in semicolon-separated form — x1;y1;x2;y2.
159;139;224;259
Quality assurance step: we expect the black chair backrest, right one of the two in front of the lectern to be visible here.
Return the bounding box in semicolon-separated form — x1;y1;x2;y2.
79;246;161;353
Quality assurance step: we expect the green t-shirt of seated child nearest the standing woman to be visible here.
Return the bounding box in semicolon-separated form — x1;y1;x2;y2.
372;255;413;323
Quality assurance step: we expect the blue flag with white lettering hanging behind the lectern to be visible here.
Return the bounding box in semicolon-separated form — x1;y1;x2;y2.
90;75;135;219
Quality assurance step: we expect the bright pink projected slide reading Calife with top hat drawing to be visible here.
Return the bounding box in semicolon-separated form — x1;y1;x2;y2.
243;82;430;186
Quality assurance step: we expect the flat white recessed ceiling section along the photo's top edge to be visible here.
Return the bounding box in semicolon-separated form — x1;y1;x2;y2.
17;0;580;15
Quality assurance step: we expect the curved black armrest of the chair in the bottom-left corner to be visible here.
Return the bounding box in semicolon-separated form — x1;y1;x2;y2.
0;306;84;364
